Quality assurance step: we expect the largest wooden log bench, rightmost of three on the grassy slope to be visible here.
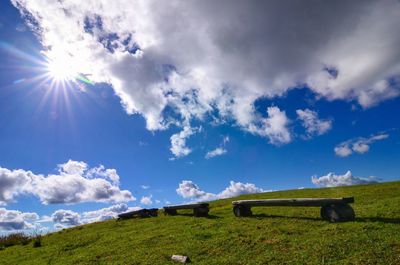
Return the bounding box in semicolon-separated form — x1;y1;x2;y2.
232;197;355;222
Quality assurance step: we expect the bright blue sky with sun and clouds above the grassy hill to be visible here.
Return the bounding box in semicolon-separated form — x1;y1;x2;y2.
0;0;400;231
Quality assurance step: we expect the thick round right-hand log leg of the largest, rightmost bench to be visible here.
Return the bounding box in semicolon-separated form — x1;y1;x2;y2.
321;204;355;222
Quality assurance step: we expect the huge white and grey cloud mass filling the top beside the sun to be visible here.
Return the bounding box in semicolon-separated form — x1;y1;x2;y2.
12;0;400;157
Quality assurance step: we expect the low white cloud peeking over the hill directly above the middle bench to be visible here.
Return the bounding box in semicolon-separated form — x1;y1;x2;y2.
176;180;267;201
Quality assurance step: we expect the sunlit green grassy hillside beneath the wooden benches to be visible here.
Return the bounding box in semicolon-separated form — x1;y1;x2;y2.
0;182;400;265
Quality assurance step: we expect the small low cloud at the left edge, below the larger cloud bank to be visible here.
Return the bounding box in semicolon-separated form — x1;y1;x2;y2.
0;208;39;231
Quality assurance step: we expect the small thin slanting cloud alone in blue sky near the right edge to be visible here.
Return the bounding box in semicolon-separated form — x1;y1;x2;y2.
334;134;389;157
